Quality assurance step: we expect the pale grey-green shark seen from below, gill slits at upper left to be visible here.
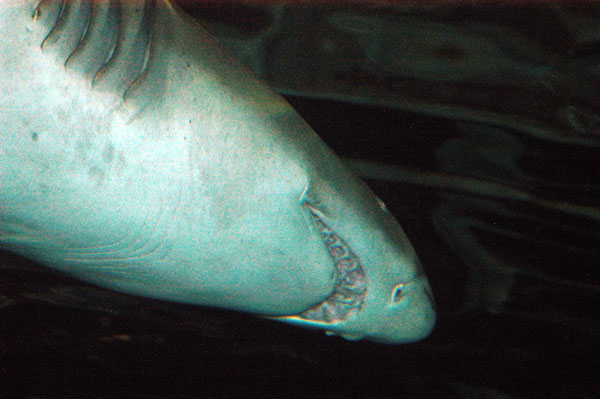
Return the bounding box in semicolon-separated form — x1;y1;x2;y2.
0;0;435;343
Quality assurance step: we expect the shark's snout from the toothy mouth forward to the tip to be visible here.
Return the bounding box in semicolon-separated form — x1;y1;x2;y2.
278;169;436;344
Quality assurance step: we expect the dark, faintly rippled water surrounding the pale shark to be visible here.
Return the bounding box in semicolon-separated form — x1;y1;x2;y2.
0;1;600;398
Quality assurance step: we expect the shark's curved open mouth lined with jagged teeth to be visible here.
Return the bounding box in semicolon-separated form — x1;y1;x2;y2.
291;204;367;323
